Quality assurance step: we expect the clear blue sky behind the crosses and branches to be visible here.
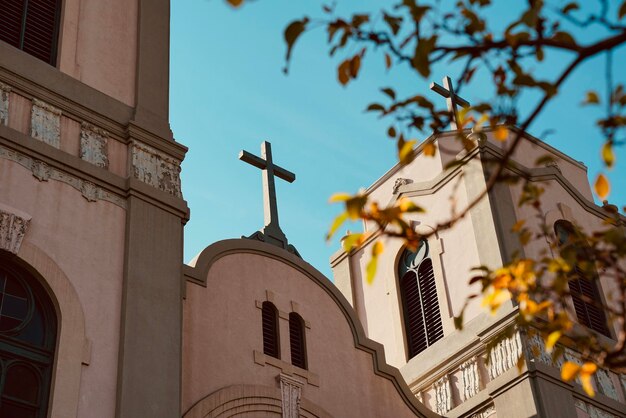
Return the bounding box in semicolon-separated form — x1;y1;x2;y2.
170;0;626;278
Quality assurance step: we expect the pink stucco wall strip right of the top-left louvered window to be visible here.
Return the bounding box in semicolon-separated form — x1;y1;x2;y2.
58;0;137;106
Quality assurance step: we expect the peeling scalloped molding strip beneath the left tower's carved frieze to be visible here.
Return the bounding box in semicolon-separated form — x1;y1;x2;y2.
0;146;126;208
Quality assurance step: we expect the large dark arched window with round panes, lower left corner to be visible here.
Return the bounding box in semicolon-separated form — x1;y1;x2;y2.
0;254;57;418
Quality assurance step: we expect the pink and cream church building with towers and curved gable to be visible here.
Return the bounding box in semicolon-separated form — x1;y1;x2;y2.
0;0;626;418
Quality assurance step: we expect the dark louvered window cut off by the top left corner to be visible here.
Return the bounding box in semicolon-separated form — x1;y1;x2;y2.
0;0;61;65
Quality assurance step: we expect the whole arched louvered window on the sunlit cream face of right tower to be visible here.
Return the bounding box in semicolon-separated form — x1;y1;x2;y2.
398;240;443;358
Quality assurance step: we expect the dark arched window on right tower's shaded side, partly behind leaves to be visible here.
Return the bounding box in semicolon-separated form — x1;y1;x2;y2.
554;220;610;337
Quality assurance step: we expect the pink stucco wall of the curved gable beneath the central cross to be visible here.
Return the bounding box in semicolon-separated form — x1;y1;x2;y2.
183;240;434;417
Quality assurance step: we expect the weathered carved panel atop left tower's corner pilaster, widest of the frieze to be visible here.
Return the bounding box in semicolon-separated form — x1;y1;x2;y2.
132;141;182;197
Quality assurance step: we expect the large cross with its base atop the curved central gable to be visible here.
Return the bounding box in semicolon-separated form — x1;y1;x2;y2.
239;141;298;255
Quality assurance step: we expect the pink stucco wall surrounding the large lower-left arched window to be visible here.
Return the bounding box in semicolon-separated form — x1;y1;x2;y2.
0;159;125;417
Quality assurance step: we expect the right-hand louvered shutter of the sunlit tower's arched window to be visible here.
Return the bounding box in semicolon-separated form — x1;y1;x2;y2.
418;258;443;346
